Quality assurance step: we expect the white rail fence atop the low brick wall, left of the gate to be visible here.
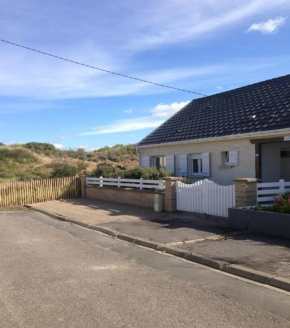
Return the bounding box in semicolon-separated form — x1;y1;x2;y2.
86;177;165;190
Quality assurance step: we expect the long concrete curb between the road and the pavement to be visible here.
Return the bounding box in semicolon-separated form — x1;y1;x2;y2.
25;205;290;292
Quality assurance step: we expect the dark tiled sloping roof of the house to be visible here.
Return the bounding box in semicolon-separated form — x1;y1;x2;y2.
137;75;290;146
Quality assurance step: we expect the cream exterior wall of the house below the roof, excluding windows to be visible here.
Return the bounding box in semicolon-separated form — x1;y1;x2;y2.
138;139;256;185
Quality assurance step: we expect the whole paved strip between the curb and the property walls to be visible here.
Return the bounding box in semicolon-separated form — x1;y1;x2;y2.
29;198;290;279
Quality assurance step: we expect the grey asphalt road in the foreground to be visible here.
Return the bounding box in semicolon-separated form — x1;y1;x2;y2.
0;211;290;328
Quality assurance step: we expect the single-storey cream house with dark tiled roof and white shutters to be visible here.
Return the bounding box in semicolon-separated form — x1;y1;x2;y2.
137;75;290;185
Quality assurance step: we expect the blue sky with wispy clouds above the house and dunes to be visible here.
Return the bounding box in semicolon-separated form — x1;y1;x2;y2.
0;0;290;150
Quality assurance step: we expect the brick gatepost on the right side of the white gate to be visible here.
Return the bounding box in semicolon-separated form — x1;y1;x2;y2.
234;178;257;207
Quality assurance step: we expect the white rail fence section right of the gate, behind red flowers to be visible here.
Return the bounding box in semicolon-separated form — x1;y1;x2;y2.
257;180;290;205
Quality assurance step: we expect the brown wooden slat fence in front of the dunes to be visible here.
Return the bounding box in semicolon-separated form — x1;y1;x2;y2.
0;176;80;207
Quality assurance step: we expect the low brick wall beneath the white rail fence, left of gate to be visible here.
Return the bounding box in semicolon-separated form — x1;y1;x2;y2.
85;186;163;209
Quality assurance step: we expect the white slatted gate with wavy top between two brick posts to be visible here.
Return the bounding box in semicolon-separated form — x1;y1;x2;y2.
176;180;236;217
